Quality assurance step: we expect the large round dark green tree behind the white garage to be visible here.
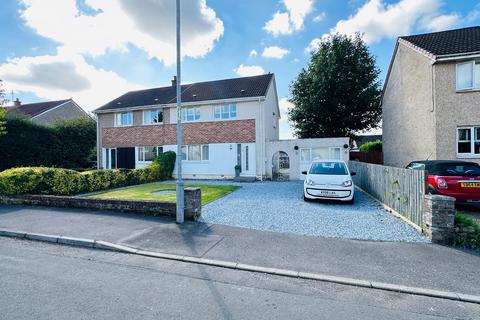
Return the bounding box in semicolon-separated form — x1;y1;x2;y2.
288;34;382;138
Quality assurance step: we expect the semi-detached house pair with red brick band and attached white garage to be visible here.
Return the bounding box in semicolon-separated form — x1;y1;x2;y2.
94;74;349;180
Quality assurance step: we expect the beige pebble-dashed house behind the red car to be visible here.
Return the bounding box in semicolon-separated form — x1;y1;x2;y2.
382;26;480;167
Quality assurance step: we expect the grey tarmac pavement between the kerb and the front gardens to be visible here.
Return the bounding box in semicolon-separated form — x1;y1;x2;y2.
0;206;480;295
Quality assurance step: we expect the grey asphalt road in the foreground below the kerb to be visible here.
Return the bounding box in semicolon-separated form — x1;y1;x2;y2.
0;238;480;320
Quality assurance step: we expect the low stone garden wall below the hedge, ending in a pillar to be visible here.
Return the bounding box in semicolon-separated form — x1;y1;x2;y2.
0;188;202;221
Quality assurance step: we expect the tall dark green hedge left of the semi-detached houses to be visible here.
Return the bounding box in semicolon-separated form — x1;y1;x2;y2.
0;115;97;171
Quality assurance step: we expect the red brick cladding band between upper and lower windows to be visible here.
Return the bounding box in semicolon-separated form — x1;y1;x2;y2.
102;120;255;148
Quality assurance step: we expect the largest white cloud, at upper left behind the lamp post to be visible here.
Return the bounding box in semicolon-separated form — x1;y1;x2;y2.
16;0;224;65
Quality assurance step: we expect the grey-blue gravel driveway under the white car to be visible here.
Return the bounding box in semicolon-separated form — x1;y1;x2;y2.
195;181;427;242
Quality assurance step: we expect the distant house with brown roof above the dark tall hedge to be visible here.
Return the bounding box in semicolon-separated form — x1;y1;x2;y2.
6;98;89;125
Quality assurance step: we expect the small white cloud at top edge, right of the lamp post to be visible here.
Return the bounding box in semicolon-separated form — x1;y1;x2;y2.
264;0;313;36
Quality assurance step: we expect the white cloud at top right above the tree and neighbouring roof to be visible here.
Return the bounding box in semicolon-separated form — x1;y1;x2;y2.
318;0;445;43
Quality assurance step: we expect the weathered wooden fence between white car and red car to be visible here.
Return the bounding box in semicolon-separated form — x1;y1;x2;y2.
348;161;426;228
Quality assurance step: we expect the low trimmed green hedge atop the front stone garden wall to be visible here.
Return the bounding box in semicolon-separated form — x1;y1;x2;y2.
0;151;176;195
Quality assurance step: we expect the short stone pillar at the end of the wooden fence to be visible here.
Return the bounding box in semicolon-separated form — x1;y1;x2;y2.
423;194;455;244
